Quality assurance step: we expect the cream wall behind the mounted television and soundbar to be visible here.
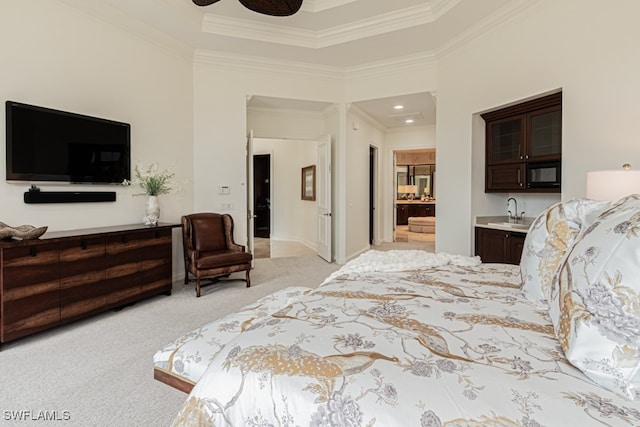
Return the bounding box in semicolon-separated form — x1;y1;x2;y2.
0;0;193;278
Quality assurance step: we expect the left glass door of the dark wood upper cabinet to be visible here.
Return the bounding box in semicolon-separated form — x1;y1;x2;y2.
487;115;524;163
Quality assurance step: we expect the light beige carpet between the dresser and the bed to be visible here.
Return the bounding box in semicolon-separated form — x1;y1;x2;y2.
0;256;339;427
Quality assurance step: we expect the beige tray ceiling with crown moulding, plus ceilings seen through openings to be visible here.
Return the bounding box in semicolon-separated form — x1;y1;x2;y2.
61;0;535;128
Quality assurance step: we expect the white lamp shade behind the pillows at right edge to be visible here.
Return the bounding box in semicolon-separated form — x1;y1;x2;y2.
587;170;640;202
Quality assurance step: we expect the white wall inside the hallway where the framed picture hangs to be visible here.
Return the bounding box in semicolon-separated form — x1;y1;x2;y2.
253;138;318;249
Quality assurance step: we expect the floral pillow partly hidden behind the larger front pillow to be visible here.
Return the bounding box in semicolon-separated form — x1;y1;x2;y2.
520;199;610;307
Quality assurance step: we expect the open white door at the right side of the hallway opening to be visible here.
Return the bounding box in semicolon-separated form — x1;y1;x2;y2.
316;135;332;262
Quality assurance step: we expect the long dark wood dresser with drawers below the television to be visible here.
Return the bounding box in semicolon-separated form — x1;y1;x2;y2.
0;224;178;343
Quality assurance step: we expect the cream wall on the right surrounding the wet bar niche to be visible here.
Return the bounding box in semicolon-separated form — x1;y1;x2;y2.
436;0;640;254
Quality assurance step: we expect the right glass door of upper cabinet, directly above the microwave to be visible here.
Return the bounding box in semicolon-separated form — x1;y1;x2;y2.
528;108;562;158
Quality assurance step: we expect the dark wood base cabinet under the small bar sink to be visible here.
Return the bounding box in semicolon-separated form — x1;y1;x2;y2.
476;227;526;264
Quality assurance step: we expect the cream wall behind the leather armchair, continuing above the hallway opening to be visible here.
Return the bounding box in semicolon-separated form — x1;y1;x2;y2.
193;52;344;258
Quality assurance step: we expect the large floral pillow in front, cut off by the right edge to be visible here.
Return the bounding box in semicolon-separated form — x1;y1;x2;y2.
549;195;640;400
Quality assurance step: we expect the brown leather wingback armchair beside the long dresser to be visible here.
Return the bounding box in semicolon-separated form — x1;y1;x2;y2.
182;213;252;297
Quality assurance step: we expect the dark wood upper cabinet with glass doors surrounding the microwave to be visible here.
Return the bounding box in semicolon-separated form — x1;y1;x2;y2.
482;93;562;193
